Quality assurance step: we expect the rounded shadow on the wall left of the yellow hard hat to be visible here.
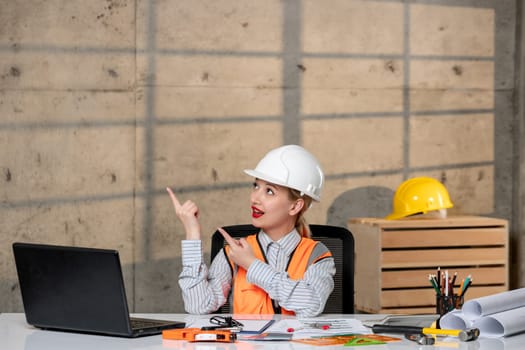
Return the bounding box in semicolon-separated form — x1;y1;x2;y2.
326;186;394;227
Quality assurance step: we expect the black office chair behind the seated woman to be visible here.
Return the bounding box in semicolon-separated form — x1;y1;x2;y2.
211;225;354;314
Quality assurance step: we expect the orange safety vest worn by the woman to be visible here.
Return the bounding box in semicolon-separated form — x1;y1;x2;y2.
224;234;332;315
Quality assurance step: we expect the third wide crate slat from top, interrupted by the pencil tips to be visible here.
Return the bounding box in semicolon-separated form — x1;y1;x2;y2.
381;266;508;289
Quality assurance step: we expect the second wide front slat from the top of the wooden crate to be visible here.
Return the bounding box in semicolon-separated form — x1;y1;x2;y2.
381;247;508;268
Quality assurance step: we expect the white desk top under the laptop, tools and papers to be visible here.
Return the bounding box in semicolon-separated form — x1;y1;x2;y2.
0;313;525;350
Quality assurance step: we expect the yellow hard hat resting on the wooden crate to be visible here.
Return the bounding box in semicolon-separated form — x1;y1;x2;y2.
386;177;454;220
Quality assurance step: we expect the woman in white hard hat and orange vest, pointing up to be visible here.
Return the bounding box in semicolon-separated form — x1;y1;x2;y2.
167;145;335;317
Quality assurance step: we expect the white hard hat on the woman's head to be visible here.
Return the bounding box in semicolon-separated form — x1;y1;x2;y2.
244;145;324;201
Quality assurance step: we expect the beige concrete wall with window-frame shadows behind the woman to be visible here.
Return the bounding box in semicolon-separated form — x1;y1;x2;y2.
0;0;523;312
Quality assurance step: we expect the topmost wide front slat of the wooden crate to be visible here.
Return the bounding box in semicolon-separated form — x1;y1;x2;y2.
381;228;507;248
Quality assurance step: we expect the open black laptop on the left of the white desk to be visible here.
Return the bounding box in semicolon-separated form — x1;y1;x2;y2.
13;242;185;338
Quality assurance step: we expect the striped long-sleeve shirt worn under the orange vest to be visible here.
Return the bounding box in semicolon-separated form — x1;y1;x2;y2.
179;229;335;317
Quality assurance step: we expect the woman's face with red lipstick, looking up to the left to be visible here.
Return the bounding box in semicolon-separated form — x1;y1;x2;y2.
250;179;300;235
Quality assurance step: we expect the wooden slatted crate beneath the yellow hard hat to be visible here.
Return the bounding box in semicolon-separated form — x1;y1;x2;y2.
348;216;509;314
